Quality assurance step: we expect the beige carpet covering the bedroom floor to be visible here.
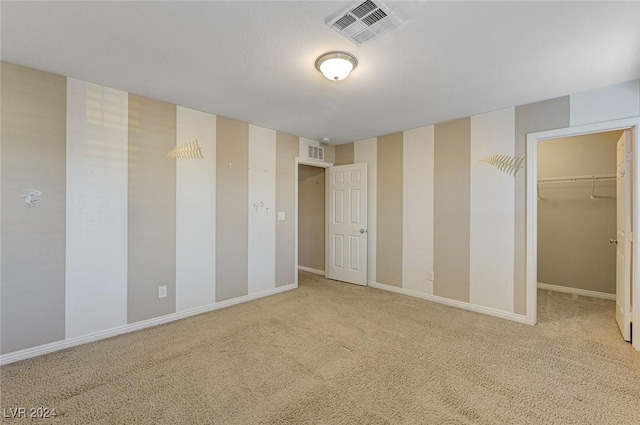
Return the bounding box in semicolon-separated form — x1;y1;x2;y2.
0;273;640;425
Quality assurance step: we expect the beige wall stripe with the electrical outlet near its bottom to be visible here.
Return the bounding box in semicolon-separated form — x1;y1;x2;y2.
127;94;176;323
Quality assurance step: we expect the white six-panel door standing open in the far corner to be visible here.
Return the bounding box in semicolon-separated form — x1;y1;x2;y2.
326;164;367;285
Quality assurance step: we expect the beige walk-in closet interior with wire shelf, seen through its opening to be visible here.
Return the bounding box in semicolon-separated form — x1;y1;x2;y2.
537;130;624;339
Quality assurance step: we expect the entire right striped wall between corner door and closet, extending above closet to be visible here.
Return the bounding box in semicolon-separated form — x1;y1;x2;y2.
336;81;640;315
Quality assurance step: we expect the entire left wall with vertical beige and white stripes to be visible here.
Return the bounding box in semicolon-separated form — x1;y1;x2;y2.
0;62;300;357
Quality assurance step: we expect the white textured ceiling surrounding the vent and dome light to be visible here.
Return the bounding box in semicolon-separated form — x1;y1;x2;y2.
0;1;640;144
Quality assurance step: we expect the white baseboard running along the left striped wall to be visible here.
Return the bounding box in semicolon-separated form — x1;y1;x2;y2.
0;283;298;366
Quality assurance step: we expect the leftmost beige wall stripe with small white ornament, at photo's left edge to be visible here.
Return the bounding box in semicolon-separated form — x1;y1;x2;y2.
0;62;67;354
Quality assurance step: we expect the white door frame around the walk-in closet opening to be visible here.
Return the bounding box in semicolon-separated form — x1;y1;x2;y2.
525;117;640;351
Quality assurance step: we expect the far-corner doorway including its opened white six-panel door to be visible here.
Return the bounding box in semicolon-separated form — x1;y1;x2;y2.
295;158;368;286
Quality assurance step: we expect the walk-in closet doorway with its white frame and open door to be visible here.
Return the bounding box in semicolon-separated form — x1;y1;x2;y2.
526;118;640;350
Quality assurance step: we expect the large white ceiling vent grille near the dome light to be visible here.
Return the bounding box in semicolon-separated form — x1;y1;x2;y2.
325;0;402;46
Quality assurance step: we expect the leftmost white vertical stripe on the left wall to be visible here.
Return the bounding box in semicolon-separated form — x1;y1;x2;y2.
65;78;129;338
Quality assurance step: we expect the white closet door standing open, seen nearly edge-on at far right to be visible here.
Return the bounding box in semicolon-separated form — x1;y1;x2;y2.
612;130;631;341
